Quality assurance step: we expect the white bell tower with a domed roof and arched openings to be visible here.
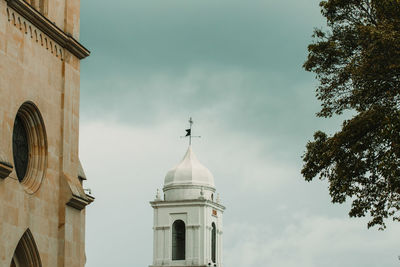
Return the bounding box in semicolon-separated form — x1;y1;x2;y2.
150;147;225;267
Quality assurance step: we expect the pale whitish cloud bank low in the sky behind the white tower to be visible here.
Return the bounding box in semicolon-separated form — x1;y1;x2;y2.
80;122;398;267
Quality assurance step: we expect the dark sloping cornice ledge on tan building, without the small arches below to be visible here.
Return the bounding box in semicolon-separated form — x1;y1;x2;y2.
6;0;90;59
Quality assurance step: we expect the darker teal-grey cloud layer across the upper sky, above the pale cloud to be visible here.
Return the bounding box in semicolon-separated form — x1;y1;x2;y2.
81;0;332;158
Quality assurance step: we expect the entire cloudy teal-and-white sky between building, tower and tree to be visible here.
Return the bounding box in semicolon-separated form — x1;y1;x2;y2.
80;0;400;267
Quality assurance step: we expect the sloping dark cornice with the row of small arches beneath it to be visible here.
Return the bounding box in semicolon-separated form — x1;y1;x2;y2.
6;0;90;59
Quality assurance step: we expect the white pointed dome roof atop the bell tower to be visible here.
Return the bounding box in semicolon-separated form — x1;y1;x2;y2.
164;146;215;189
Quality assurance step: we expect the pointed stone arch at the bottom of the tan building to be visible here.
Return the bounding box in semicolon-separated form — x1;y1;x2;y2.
10;229;42;267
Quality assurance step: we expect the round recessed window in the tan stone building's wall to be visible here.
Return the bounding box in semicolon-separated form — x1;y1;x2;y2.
13;102;47;193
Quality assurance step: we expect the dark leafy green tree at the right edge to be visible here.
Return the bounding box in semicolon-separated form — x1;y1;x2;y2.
302;0;400;229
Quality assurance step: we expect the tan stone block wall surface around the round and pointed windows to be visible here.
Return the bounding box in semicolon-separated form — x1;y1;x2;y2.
0;0;92;267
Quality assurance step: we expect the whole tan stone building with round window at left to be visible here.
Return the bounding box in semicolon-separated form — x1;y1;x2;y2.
0;0;93;267
